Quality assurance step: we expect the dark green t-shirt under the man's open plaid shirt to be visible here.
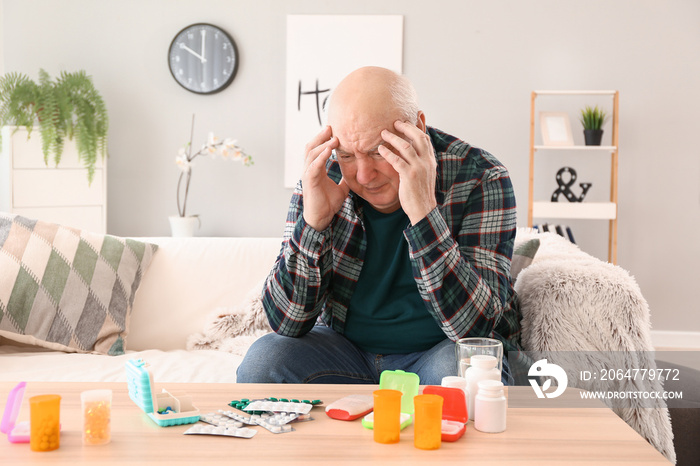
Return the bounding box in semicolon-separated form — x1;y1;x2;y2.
344;202;447;354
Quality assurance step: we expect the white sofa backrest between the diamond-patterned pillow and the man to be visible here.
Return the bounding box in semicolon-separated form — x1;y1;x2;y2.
126;238;281;351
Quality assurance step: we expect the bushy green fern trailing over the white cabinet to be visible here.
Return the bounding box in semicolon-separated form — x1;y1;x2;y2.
0;69;109;182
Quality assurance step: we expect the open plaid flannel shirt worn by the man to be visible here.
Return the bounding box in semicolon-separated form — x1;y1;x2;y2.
263;127;522;355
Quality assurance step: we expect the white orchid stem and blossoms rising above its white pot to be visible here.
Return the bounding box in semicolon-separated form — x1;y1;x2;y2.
175;115;253;217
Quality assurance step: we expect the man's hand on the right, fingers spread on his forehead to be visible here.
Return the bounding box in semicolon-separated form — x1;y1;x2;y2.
379;120;437;225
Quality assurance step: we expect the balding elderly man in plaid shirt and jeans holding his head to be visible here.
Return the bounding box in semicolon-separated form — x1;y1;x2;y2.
238;67;521;385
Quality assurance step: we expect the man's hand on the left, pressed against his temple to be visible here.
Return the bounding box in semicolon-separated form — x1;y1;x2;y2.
301;126;350;231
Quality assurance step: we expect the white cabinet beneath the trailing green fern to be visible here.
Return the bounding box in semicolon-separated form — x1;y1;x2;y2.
0;126;107;233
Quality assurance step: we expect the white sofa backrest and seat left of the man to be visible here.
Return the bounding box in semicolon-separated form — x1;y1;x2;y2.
0;238;280;383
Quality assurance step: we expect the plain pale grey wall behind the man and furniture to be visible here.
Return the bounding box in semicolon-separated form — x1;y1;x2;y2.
0;0;700;331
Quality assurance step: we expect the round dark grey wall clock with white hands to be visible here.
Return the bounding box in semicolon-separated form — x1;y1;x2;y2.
168;23;238;94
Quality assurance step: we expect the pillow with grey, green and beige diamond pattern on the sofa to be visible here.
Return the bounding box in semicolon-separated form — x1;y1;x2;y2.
0;213;157;355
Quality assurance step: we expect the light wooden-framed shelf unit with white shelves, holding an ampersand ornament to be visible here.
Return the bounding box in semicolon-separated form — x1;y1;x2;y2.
527;90;620;264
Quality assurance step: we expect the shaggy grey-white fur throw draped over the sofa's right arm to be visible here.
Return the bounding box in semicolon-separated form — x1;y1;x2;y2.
515;230;676;463
